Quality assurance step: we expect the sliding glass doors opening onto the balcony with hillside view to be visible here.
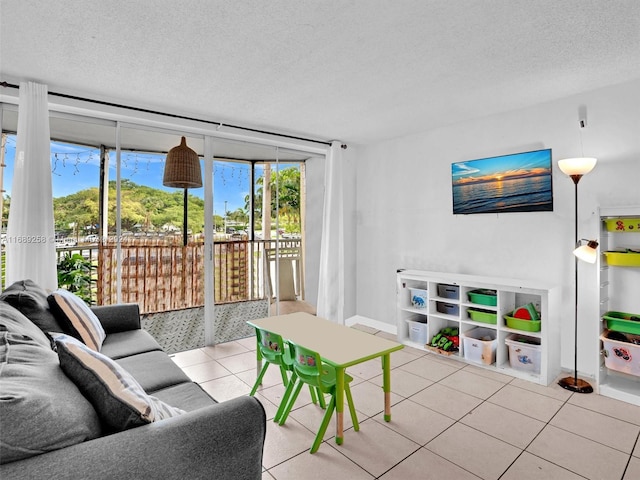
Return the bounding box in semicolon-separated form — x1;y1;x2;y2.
0;100;318;351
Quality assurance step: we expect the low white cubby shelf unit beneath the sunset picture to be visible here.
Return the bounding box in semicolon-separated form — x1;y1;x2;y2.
396;270;560;385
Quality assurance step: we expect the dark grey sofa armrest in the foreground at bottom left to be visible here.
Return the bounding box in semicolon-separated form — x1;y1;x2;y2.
0;396;266;480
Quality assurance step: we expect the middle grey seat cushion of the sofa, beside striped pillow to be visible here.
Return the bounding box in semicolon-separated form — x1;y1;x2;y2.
116;351;191;393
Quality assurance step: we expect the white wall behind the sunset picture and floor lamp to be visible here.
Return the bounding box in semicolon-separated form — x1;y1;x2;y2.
355;80;640;375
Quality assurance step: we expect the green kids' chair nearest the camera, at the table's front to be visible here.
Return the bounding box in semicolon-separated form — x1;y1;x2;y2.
275;341;360;453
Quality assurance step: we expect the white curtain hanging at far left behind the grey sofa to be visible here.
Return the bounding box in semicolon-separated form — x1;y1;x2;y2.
5;82;58;290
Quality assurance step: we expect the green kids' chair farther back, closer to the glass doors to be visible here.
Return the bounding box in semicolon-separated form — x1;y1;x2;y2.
249;328;326;421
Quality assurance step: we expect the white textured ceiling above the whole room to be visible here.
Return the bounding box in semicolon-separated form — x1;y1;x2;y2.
0;0;640;144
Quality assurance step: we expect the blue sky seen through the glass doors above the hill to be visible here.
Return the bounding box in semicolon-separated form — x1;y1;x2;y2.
4;135;290;215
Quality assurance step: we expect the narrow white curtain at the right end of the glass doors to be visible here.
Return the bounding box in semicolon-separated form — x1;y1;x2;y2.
316;142;344;324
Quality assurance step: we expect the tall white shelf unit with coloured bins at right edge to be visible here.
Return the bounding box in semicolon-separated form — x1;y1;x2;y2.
596;206;640;405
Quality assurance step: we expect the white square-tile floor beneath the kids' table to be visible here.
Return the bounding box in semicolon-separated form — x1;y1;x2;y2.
173;326;640;480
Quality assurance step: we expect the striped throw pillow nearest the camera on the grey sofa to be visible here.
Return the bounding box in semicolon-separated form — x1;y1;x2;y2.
52;333;185;431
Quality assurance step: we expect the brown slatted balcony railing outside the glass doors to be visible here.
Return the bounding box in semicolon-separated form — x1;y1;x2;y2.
51;238;301;313
